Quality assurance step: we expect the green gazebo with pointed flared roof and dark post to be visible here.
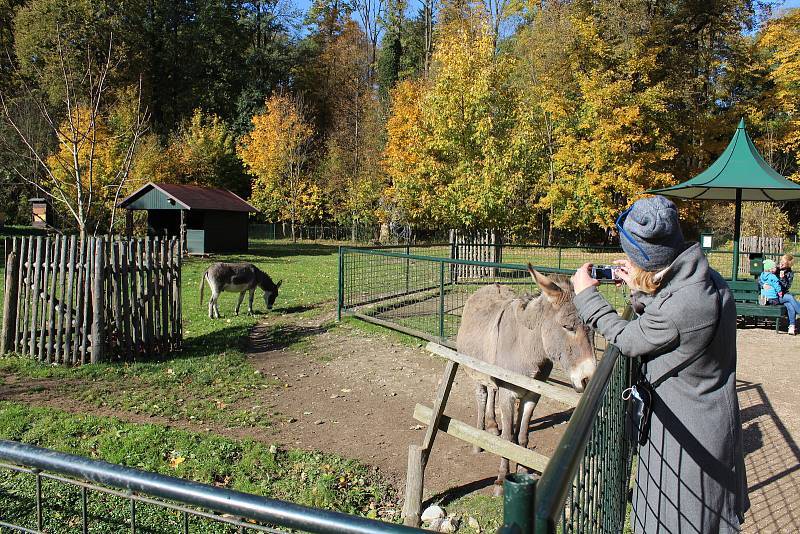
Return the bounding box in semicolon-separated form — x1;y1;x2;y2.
648;119;800;280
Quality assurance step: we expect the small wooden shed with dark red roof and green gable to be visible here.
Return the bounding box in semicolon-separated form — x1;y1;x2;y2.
119;182;258;254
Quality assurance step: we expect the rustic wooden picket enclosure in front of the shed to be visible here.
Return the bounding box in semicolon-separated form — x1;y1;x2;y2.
0;235;182;365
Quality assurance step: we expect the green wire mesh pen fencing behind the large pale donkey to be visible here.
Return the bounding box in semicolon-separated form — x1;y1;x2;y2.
338;245;626;348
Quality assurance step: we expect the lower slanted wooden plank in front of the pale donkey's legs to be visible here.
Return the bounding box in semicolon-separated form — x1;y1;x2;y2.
414;404;550;473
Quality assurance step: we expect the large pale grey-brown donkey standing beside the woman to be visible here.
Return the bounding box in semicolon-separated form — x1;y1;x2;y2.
456;264;596;495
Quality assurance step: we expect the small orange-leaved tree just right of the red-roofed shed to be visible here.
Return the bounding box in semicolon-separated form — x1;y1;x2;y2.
238;94;322;240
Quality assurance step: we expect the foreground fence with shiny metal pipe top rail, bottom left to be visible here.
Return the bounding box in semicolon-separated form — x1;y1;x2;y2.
0;440;425;534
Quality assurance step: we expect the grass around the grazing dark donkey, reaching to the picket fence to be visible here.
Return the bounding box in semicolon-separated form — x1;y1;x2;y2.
0;243;338;427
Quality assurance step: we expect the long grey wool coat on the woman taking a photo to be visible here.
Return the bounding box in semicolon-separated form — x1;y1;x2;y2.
575;244;750;534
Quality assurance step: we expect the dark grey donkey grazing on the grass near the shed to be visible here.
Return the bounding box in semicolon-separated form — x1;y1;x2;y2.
200;262;283;319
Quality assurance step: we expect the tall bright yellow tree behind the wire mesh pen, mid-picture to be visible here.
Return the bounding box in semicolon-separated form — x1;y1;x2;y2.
385;10;530;232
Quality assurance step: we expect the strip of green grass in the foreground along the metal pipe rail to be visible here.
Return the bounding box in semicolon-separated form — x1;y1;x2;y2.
0;402;398;533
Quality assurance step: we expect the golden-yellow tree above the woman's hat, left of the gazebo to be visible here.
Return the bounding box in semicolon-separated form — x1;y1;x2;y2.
541;8;676;229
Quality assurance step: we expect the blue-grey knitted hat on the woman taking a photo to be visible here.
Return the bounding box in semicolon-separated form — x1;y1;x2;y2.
620;196;684;271
